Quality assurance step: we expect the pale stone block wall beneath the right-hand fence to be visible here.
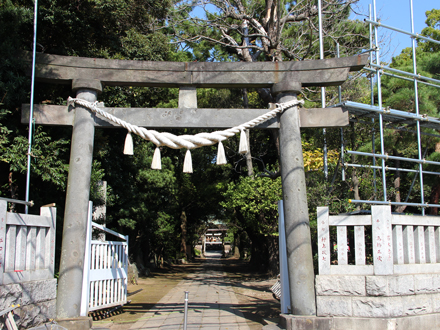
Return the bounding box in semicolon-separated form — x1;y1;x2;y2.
316;274;440;318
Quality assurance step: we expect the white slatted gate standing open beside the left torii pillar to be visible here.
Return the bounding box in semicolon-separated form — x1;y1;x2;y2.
81;202;128;316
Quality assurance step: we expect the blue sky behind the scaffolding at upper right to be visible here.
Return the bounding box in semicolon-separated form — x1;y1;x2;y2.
353;0;440;61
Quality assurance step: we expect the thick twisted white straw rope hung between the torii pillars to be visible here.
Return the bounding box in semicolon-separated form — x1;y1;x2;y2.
67;97;304;149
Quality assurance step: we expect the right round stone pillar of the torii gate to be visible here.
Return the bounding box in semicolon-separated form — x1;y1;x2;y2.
272;81;316;315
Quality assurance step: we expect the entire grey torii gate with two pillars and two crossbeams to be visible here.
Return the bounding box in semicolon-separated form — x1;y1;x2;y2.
22;54;368;329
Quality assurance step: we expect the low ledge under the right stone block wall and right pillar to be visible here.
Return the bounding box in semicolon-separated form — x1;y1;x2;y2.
280;313;440;330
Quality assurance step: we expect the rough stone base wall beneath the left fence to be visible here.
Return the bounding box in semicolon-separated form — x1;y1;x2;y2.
0;279;57;328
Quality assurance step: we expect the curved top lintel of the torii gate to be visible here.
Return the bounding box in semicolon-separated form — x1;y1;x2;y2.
25;53;368;88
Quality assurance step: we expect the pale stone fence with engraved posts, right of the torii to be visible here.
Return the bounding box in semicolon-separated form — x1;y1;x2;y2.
318;205;440;275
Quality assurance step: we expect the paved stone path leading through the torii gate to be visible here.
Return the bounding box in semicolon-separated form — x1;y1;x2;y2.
130;252;250;330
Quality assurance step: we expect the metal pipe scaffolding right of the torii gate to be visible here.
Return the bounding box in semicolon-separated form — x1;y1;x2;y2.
335;0;440;215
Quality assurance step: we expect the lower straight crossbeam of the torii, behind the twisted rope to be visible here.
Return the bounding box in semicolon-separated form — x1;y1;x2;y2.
21;104;349;129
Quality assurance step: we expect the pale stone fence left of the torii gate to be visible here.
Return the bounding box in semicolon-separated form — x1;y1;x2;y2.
0;200;56;285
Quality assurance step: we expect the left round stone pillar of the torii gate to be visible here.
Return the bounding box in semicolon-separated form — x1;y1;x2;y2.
56;79;102;329
